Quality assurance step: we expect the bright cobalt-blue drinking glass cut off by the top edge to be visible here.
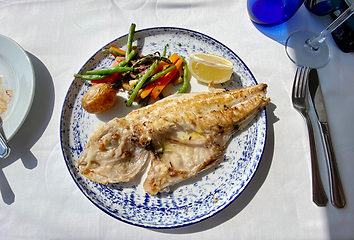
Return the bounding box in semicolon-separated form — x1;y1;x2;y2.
247;0;304;26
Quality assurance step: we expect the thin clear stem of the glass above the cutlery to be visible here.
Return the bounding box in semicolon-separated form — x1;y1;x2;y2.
306;3;354;51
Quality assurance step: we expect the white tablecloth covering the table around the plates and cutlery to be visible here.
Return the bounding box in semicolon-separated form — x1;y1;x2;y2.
0;0;354;240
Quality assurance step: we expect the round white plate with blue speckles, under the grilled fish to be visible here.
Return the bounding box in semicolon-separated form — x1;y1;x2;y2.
60;28;267;228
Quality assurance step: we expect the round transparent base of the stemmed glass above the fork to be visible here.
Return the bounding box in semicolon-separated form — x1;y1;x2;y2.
285;31;330;68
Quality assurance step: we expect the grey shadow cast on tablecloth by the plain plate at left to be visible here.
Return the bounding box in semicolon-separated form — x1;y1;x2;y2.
0;52;55;205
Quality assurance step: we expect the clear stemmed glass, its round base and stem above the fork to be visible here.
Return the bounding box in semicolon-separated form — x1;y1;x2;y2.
285;3;354;68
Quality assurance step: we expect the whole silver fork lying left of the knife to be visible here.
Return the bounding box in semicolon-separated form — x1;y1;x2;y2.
292;67;328;206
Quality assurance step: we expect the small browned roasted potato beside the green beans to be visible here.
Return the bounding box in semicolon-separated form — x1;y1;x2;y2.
81;83;117;114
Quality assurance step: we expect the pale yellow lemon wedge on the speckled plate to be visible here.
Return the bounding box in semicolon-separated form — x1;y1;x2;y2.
189;52;233;84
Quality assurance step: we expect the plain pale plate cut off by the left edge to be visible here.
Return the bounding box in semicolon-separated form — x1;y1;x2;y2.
0;35;35;140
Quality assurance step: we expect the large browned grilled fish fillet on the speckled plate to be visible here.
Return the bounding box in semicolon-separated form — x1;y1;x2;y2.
76;84;270;195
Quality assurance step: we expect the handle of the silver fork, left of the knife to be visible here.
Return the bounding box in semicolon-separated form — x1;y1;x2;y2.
304;114;328;207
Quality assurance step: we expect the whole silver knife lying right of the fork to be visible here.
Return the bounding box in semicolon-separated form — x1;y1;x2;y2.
309;69;346;208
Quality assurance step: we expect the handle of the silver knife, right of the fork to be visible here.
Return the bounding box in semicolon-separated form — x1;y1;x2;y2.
320;122;346;208
